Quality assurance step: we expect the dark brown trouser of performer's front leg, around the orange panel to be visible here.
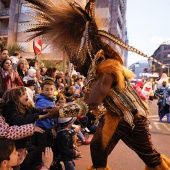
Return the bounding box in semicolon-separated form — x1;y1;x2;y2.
90;116;119;170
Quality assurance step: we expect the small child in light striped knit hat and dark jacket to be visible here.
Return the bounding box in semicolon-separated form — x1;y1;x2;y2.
53;117;80;170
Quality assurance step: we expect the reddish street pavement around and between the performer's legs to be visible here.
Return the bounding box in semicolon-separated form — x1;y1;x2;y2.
75;100;170;170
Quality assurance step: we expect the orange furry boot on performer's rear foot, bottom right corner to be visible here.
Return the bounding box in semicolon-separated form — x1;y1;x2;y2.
145;154;170;170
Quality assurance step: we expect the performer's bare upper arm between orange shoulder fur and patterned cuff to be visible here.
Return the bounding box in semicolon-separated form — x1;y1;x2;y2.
86;74;114;110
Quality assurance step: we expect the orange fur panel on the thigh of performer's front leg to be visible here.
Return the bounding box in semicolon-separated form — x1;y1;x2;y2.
102;113;123;148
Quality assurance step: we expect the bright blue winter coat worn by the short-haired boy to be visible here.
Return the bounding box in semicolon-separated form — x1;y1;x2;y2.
36;93;55;129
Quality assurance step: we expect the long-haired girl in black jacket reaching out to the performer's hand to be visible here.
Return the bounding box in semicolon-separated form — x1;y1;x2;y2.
2;86;54;169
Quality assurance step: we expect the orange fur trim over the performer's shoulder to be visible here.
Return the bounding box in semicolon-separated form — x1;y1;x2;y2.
97;59;134;89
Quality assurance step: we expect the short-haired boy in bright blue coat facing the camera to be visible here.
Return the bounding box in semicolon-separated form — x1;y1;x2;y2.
34;80;55;151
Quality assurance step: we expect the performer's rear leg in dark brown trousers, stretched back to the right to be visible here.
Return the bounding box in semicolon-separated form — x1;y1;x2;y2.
116;116;170;170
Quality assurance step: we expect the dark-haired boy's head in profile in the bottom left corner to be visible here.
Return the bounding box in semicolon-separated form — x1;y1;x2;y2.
0;138;18;170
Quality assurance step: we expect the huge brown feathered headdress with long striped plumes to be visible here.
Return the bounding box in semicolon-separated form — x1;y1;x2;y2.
25;0;163;65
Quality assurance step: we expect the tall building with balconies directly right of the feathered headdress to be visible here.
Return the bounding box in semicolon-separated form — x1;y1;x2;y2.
96;0;128;67
